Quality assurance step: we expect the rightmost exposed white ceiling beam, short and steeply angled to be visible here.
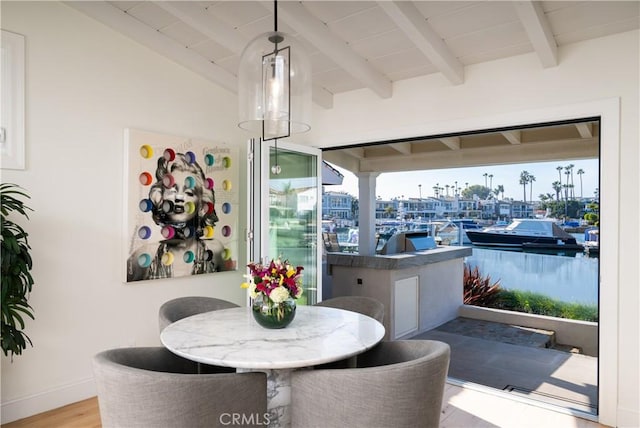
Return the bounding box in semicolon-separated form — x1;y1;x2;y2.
512;1;558;68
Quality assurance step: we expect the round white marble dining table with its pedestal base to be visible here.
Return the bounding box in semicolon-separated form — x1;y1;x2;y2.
160;306;385;427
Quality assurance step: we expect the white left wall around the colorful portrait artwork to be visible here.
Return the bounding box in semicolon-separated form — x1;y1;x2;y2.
1;1;246;423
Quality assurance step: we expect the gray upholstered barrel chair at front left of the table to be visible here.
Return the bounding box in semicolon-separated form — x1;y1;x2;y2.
93;347;267;428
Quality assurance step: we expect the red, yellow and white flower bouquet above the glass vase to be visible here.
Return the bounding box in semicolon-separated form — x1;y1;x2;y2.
241;258;304;304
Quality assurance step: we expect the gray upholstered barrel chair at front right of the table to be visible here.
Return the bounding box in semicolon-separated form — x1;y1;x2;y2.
291;340;451;428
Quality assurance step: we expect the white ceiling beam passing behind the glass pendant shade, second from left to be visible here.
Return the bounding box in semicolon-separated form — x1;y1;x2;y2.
154;1;333;109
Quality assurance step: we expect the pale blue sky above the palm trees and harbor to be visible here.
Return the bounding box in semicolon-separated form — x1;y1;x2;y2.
325;159;599;201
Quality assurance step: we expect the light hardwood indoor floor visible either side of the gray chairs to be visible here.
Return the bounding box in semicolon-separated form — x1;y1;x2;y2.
2;384;603;428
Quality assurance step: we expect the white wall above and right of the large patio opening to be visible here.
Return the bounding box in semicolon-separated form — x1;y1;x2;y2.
305;31;640;427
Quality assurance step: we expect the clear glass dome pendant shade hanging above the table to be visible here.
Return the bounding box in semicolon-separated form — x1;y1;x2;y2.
238;28;311;141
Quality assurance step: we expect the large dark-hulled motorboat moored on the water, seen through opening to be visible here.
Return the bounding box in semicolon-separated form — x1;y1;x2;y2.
467;219;584;250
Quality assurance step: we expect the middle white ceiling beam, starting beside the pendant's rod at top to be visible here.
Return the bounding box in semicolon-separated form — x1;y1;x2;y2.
261;1;393;98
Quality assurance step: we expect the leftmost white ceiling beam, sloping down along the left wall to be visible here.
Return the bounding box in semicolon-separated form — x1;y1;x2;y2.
65;1;238;94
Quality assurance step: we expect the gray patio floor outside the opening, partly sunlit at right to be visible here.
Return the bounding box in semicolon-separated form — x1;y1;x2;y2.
411;318;598;415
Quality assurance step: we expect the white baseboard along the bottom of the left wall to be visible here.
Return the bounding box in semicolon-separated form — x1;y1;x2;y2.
0;377;96;424
